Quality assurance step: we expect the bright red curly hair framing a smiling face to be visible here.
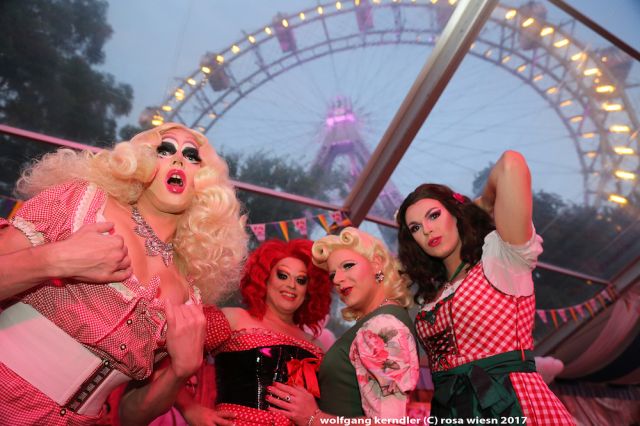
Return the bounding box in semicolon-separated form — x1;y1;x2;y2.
240;239;331;337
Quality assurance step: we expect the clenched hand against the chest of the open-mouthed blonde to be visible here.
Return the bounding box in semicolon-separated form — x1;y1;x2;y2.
52;222;132;283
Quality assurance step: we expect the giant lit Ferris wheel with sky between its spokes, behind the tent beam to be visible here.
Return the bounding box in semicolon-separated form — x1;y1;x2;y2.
148;2;640;210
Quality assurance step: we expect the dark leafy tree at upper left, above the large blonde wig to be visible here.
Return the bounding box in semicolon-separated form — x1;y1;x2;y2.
0;0;133;194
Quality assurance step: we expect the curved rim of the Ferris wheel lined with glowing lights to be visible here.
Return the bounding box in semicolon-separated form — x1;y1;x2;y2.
152;0;640;205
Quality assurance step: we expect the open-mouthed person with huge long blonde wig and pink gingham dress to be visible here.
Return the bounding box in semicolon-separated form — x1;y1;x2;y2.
0;123;246;424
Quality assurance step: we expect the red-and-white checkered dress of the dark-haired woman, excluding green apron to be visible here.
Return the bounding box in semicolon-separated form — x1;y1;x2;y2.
416;262;575;425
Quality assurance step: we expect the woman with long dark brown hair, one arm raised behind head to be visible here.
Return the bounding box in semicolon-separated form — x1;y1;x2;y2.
397;151;574;425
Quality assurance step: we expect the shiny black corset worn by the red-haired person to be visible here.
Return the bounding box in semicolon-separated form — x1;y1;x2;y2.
215;345;316;410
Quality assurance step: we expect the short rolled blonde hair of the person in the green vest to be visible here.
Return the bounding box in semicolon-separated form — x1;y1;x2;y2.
311;227;412;321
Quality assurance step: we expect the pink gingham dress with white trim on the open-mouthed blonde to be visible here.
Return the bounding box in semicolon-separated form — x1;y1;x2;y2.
0;181;200;425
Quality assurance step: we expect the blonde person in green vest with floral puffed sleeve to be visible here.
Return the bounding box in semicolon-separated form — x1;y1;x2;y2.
267;227;418;426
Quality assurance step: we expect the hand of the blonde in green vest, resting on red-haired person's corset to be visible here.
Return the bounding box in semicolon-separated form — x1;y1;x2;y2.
267;382;318;425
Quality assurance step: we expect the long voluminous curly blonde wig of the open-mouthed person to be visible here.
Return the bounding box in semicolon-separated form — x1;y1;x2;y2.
17;123;247;303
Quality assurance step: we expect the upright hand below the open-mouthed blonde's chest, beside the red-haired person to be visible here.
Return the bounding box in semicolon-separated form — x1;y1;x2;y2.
165;299;206;379
